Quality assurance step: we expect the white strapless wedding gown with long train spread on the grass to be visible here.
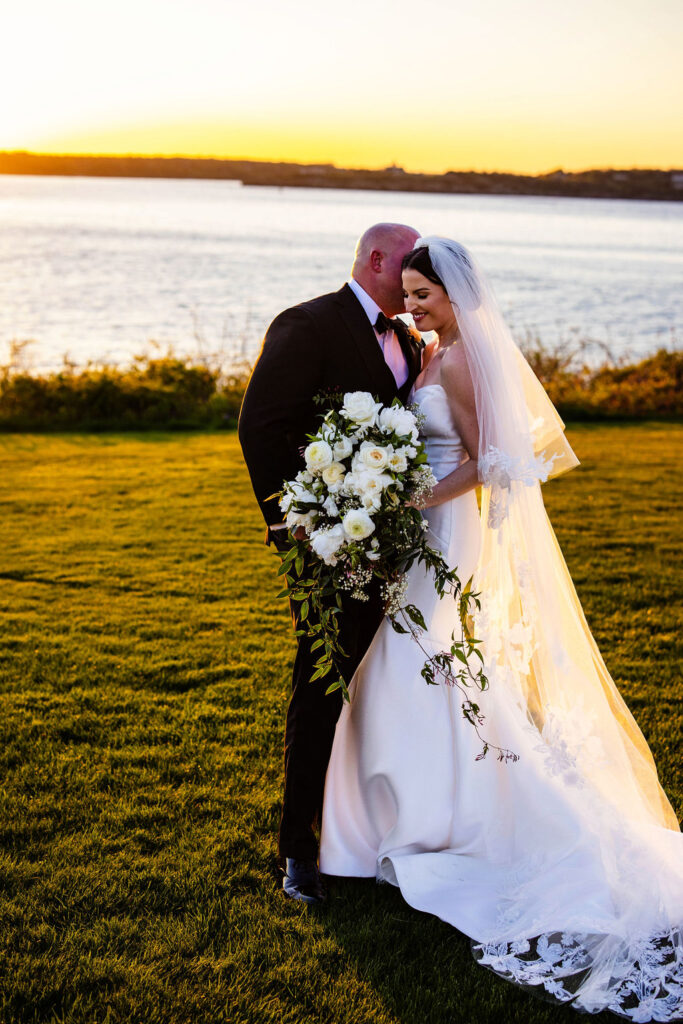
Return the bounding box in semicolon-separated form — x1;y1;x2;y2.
321;384;683;1021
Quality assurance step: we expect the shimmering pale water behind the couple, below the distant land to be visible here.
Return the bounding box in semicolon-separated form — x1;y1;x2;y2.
0;176;683;369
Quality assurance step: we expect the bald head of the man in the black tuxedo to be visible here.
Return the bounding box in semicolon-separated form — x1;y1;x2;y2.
351;223;420;316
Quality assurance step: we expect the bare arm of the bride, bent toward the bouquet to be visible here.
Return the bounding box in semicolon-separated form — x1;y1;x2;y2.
411;344;479;508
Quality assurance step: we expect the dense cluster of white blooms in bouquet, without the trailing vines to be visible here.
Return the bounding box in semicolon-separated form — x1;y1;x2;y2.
280;391;436;607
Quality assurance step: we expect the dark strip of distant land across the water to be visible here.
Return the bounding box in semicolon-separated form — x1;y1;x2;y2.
0;152;683;202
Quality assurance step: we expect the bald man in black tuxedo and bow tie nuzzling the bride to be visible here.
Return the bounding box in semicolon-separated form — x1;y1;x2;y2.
239;223;422;903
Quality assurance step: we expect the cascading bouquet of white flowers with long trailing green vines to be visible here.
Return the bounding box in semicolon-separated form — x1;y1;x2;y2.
273;391;509;757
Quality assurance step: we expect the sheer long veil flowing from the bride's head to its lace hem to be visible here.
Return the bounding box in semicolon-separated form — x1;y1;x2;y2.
415;237;683;1020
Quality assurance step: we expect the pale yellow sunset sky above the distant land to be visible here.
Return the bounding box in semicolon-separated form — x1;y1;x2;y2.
5;0;683;173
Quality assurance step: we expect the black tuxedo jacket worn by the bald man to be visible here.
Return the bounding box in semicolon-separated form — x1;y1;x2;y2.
239;285;423;525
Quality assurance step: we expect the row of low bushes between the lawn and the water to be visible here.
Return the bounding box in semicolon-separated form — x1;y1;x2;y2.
0;340;683;431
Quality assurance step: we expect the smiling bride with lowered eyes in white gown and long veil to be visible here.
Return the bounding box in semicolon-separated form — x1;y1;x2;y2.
321;238;683;1021
